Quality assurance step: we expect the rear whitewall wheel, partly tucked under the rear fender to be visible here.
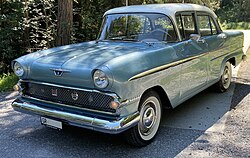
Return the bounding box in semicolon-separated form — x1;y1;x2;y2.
215;62;232;93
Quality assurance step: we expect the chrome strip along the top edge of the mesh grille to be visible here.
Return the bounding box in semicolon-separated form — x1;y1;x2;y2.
19;80;119;99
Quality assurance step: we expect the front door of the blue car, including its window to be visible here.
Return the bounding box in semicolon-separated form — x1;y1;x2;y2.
176;12;208;102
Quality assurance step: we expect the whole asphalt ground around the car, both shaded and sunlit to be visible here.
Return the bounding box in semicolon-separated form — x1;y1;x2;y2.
0;33;250;158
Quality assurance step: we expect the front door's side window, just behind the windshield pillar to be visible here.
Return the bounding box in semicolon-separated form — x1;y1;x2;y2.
176;14;197;40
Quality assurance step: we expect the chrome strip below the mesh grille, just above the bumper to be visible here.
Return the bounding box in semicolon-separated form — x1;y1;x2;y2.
22;95;117;115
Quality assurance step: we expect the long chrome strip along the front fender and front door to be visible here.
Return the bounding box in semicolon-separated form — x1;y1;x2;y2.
128;53;208;81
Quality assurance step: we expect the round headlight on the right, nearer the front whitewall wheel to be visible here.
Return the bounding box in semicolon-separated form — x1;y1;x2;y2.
93;70;109;88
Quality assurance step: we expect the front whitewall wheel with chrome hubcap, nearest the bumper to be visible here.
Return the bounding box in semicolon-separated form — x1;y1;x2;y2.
125;91;161;147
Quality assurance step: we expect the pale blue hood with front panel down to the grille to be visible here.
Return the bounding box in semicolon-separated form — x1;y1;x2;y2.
23;42;155;88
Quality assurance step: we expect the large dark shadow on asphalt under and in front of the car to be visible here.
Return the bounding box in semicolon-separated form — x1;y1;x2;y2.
0;81;249;157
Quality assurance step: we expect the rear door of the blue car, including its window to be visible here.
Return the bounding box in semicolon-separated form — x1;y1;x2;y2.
197;12;227;84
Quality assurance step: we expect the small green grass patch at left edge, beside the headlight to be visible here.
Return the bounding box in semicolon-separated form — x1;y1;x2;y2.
0;73;18;92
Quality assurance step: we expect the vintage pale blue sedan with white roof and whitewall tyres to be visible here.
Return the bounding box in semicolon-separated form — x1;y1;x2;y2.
12;4;244;146
